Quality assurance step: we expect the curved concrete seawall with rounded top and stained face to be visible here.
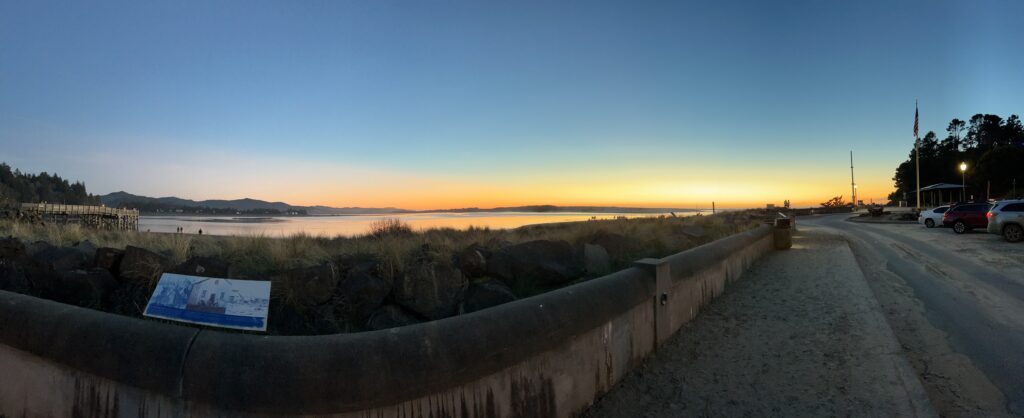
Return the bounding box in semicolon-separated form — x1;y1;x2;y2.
0;225;772;417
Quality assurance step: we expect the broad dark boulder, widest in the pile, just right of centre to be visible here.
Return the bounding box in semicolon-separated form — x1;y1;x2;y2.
487;240;584;293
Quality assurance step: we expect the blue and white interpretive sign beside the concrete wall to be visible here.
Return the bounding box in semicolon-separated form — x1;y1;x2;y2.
144;273;270;331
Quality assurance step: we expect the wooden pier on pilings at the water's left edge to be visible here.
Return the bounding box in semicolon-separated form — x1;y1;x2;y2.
19;203;138;231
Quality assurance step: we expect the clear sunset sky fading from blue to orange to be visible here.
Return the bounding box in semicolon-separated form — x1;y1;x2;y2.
0;0;1024;209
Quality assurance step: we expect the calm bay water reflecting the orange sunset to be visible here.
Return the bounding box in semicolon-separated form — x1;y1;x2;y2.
138;212;696;237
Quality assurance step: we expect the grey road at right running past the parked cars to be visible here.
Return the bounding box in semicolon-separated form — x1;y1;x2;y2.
800;216;1024;417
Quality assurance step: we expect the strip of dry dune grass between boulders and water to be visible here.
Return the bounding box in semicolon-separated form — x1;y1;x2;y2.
0;211;759;279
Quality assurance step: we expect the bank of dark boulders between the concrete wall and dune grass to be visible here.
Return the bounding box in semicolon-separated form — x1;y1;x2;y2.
0;214;753;335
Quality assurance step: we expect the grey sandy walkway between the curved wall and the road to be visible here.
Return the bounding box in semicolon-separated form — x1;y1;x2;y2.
587;226;934;418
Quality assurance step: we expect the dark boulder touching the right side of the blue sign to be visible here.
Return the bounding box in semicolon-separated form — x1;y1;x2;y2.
270;262;338;305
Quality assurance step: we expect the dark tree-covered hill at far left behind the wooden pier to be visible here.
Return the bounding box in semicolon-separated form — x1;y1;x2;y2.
0;163;99;205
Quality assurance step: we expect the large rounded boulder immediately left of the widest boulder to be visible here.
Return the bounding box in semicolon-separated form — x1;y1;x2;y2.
393;256;469;320
